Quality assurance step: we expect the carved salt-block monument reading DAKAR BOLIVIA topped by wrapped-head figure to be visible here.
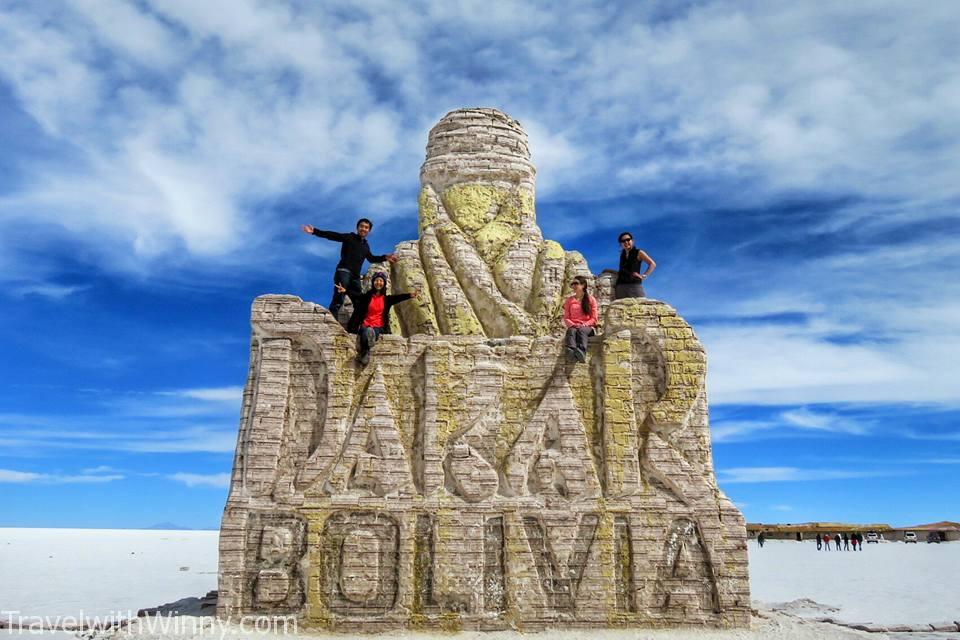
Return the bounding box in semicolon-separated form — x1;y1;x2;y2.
218;109;750;631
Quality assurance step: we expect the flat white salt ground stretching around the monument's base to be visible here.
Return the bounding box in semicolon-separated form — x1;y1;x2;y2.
0;529;960;640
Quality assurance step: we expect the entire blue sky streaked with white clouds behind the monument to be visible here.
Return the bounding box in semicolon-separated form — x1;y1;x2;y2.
0;0;960;528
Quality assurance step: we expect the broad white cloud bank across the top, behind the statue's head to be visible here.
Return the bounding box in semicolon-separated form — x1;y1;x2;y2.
0;0;960;276
